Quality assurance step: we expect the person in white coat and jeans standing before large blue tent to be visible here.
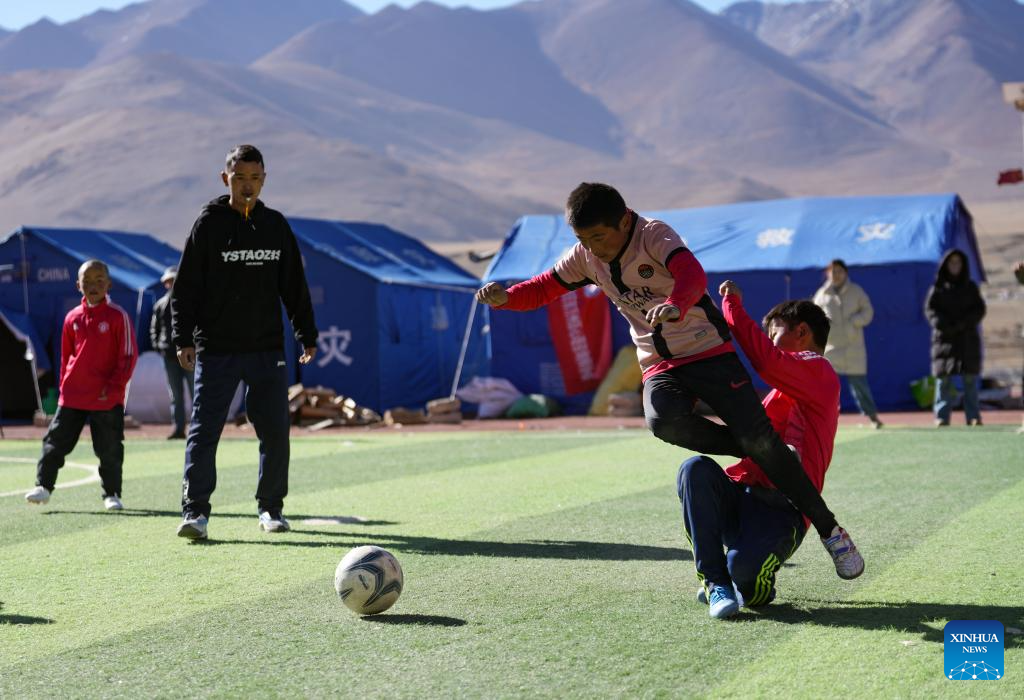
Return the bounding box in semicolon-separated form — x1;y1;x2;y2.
814;260;882;428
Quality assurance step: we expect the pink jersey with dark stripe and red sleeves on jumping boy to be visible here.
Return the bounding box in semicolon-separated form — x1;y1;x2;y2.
501;214;733;380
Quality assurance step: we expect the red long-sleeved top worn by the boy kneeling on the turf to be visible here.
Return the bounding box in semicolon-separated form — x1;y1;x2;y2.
722;295;840;493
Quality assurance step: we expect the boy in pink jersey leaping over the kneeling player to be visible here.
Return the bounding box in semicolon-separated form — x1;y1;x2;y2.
476;182;863;578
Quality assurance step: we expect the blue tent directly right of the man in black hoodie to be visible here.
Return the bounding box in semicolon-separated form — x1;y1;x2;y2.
288;217;486;411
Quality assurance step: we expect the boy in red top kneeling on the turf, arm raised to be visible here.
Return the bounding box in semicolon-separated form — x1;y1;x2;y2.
677;281;859;618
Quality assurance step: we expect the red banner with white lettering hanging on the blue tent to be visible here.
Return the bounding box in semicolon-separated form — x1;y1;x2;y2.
548;286;611;396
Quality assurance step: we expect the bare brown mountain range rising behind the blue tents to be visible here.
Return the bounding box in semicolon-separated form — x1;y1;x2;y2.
0;0;1024;246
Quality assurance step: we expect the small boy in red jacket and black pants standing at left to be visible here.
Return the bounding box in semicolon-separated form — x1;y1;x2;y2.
25;260;138;511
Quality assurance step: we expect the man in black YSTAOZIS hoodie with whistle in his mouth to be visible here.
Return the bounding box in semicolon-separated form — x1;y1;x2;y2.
171;145;317;539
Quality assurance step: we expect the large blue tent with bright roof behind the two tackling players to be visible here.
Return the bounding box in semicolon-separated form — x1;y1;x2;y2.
484;194;984;410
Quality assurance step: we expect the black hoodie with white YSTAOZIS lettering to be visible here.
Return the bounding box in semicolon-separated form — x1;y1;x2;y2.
171;194;317;354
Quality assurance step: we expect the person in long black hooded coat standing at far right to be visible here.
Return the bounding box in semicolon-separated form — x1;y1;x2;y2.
925;250;985;427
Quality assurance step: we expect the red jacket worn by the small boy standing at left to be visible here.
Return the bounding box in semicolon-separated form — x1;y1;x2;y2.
60;298;138;410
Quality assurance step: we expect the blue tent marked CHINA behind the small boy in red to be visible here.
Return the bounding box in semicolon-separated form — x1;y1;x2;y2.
0;226;181;374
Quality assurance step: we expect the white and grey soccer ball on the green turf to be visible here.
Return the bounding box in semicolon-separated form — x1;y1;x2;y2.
334;544;406;615
